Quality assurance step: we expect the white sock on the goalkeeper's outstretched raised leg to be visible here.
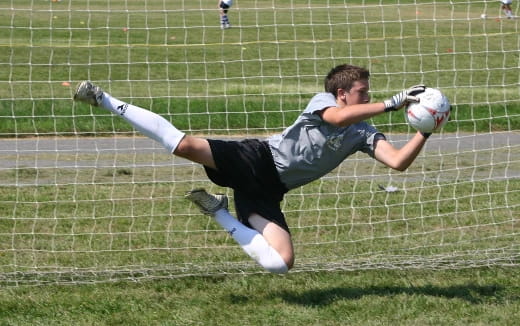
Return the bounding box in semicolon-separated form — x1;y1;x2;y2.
101;93;185;154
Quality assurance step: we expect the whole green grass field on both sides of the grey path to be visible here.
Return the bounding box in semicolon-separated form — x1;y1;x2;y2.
0;0;520;325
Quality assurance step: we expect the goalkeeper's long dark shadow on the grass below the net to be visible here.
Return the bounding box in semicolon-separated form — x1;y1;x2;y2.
278;284;503;306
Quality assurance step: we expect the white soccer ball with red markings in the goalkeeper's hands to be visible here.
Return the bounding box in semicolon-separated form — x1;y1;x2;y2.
405;87;450;132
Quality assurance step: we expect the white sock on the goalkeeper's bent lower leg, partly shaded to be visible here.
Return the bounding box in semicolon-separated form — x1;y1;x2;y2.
215;209;289;274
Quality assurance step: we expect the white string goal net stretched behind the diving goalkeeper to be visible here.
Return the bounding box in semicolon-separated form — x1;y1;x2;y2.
0;0;520;286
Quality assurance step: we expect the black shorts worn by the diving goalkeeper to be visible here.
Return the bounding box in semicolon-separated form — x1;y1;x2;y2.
204;139;289;232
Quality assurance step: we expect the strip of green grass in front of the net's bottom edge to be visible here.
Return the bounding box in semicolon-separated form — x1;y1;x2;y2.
0;268;520;326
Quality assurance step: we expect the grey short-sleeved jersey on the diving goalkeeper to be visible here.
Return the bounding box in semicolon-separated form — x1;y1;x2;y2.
268;93;384;189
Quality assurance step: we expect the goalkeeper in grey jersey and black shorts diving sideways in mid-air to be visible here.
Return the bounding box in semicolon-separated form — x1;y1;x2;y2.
74;64;429;273
